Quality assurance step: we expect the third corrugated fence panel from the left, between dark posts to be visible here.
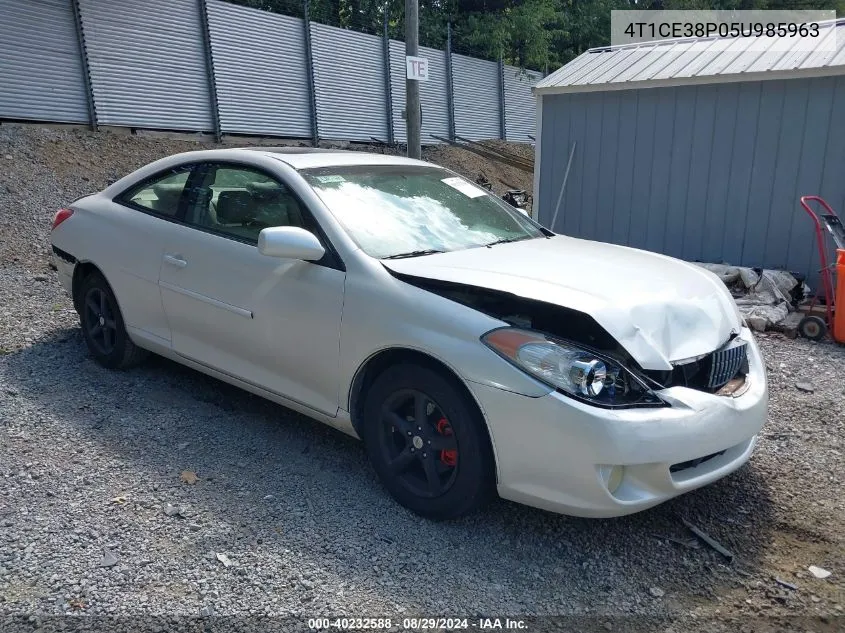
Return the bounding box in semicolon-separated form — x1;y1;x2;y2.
208;0;311;137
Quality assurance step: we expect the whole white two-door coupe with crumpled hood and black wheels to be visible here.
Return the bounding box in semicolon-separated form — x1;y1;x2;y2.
52;147;767;518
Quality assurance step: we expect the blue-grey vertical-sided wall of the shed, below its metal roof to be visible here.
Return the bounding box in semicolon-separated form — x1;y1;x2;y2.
538;77;845;283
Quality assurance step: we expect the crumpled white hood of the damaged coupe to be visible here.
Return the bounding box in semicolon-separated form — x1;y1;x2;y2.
382;235;742;369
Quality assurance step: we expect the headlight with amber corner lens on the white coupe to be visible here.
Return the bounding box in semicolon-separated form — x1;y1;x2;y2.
481;328;665;407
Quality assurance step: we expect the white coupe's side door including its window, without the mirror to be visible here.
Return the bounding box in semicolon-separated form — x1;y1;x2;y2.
159;163;346;415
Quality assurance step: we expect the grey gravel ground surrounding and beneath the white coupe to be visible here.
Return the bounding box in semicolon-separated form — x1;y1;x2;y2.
0;125;845;631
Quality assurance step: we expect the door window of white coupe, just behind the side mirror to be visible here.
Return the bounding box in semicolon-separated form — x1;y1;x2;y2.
185;164;305;243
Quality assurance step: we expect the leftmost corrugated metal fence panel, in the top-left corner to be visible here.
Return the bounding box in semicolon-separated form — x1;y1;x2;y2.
0;0;88;123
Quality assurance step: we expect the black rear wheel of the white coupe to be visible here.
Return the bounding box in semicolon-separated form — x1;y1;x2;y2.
78;272;149;369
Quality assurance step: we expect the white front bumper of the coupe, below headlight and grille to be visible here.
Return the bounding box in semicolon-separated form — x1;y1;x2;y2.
469;329;768;517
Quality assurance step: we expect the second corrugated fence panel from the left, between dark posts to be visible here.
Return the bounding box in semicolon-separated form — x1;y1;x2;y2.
80;0;213;130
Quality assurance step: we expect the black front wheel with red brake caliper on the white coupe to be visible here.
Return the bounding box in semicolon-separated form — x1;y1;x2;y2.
363;364;494;520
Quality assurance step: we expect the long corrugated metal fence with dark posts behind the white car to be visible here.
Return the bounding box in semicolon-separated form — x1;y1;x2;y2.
0;0;540;143
